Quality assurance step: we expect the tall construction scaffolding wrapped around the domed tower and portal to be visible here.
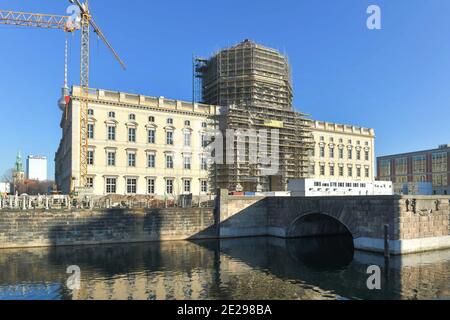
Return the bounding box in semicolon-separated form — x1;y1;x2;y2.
194;40;313;191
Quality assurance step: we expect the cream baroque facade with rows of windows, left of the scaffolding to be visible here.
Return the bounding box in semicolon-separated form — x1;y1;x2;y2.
55;87;218;196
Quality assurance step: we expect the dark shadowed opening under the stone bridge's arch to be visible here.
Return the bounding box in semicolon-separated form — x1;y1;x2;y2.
286;212;356;239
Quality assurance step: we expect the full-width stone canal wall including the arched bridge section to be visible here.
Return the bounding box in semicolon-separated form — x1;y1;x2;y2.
0;189;450;255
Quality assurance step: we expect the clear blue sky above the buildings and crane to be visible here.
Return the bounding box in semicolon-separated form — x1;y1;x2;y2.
0;0;450;177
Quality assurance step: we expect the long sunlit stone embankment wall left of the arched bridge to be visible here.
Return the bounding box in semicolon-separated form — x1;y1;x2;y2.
0;208;217;249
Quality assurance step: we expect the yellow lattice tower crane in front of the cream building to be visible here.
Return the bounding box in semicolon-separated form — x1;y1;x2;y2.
0;0;125;189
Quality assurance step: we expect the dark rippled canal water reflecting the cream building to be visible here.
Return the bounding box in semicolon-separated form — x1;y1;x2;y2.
0;236;450;300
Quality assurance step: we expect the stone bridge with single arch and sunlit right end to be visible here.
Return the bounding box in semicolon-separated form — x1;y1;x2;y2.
217;189;450;254
